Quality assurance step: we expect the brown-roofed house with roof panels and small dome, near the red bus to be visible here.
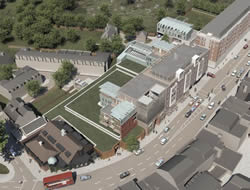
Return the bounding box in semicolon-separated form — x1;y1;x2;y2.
23;120;94;169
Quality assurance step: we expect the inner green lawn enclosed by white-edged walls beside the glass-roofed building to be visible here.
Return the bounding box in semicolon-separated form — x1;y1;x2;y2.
68;71;132;123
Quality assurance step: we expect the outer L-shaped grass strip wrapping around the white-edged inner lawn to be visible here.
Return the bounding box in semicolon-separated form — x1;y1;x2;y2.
45;67;129;151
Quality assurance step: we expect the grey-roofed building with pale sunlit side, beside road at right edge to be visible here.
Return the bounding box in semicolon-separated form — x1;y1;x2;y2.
208;108;249;151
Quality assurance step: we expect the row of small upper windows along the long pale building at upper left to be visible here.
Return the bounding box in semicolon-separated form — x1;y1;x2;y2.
16;56;105;66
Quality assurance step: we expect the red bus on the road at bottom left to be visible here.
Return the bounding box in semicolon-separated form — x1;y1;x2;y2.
43;172;74;190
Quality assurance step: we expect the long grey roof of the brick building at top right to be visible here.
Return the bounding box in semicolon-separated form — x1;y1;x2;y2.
201;0;250;38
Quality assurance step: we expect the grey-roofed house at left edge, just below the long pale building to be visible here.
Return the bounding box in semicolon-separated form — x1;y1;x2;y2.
0;66;43;100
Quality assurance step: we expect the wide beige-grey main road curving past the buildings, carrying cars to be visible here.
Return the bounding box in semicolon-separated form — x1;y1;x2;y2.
0;43;250;190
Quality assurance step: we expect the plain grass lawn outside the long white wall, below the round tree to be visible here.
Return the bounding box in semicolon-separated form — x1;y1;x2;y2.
32;87;72;113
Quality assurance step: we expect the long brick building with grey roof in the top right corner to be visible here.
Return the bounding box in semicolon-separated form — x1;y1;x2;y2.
195;0;250;67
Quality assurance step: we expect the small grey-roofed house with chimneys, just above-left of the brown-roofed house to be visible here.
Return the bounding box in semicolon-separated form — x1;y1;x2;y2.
4;98;36;128
